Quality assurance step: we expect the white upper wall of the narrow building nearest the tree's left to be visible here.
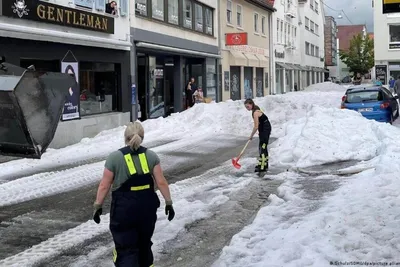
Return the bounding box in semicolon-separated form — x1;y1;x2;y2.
299;0;325;68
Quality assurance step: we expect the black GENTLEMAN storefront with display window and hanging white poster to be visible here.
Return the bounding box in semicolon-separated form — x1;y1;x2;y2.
0;0;131;148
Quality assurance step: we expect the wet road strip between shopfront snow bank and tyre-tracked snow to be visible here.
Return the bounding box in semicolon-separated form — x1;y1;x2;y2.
0;137;266;266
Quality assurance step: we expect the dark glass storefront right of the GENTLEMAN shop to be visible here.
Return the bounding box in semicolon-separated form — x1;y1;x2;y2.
132;29;220;120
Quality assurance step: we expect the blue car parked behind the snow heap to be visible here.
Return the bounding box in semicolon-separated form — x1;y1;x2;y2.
341;85;399;124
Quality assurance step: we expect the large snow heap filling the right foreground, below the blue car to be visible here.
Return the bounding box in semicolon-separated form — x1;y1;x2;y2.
214;107;400;267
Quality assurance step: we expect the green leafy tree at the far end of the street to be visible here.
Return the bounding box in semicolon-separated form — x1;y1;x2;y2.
339;34;375;75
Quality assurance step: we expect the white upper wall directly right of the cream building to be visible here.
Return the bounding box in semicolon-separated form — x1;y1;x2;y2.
272;0;304;64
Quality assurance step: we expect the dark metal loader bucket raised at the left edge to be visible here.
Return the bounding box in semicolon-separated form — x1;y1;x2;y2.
0;63;76;159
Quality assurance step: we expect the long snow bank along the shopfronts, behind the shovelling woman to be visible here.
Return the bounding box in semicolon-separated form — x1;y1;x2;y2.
0;83;345;180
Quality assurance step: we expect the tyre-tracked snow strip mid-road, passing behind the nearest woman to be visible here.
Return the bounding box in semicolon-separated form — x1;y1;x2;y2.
0;158;254;267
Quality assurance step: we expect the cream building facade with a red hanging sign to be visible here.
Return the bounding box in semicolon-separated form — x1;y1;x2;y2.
219;0;274;100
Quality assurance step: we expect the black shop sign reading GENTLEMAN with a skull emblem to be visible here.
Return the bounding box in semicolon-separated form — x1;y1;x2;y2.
2;0;114;34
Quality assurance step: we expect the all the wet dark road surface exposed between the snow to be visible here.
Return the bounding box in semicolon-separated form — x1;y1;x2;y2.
0;137;356;267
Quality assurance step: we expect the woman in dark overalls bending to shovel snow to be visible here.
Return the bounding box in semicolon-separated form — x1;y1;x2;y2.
244;98;272;172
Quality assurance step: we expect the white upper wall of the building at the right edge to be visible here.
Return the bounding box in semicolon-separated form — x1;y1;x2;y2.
374;0;400;61
